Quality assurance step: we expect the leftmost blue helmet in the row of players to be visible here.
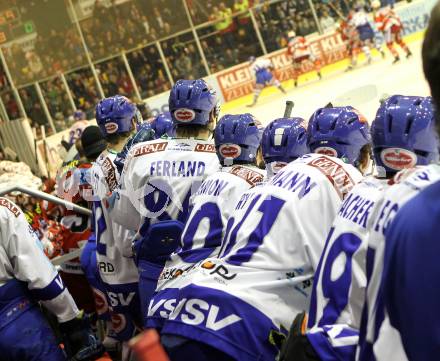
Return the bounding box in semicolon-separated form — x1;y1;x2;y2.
95;95;142;136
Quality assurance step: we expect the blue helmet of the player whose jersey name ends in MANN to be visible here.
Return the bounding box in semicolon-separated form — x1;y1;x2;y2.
307;106;371;166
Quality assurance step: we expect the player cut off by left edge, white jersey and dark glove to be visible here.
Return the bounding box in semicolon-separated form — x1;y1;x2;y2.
0;198;102;361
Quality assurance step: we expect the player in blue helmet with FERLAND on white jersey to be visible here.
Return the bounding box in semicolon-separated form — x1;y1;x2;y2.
114;79;220;326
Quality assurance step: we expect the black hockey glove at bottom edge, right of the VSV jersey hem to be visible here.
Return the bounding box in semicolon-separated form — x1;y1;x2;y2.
279;311;320;361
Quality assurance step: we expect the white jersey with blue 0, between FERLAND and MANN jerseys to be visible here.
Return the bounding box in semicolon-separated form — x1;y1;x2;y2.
147;165;265;328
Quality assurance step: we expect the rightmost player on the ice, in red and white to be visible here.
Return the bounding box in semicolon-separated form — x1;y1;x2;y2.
371;0;412;63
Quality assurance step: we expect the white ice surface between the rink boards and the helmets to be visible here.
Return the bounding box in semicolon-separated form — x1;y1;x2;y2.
222;41;429;124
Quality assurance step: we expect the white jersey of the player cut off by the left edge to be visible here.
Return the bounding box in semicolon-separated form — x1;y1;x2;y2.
0;198;79;322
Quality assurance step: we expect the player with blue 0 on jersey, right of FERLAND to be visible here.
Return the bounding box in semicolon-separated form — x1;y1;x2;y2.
146;114;265;328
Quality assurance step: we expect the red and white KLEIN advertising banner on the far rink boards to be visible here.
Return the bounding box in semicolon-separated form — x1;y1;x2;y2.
217;33;347;102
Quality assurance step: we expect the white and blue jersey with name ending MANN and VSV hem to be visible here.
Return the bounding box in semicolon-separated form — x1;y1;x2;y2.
163;154;362;360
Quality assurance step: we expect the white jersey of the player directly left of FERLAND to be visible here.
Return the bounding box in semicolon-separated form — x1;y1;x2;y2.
91;151;139;285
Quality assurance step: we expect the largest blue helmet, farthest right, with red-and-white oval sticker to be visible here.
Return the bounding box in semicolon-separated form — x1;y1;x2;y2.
371;95;439;175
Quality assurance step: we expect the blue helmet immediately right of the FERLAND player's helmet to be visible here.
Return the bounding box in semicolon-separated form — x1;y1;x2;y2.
214;113;262;164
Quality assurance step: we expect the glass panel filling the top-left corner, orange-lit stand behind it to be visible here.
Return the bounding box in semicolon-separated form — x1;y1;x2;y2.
0;0;87;86
